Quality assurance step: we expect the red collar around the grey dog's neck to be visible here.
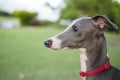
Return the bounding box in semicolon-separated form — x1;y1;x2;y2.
79;62;110;77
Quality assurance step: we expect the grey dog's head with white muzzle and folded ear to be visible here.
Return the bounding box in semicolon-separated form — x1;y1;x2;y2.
44;15;118;50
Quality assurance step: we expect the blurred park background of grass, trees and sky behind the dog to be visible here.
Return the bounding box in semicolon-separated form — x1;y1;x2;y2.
0;0;120;80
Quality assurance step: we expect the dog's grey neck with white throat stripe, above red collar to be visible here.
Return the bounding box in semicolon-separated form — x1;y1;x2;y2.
79;35;109;80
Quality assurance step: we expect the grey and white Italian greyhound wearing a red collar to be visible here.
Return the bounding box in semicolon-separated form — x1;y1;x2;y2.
44;15;120;80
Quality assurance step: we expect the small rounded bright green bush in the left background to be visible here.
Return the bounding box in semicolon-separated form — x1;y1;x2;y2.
12;10;37;25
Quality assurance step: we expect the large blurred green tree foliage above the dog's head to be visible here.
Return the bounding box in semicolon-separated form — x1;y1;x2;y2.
60;0;120;29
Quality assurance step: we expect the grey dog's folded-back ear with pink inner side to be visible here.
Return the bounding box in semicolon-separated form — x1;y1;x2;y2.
92;15;118;30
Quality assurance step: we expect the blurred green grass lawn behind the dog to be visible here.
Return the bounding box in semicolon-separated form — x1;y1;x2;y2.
0;28;120;80
